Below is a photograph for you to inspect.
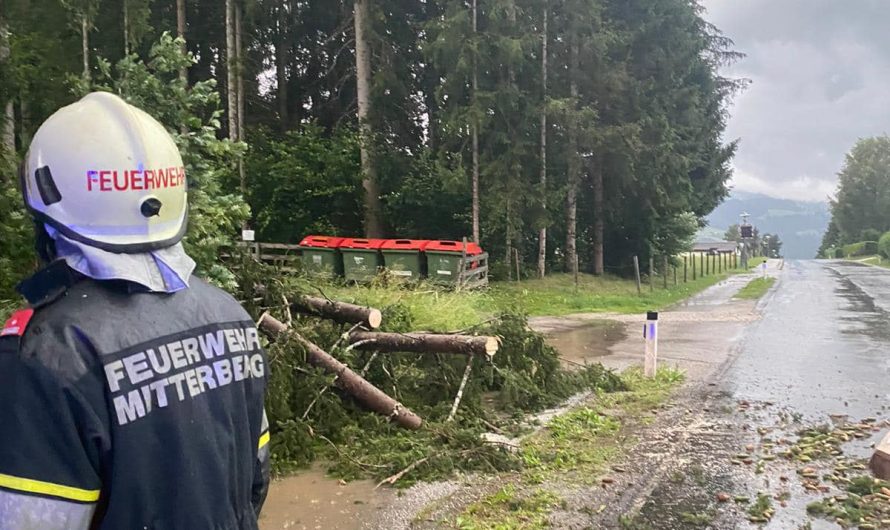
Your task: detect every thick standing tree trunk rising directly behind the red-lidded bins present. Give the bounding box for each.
[353,0,383,237]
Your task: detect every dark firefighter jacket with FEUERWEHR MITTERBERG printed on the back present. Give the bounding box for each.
[0,262,269,530]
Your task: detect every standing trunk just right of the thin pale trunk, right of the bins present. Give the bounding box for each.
[566,36,581,285]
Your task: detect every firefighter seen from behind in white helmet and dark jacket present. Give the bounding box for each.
[0,93,269,530]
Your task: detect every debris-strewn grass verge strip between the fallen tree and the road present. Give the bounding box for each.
[442,368,684,530]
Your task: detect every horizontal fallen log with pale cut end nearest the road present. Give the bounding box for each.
[349,331,499,357]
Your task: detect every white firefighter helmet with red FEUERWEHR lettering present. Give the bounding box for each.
[21,92,187,253]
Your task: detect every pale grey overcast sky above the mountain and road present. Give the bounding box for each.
[703,0,890,201]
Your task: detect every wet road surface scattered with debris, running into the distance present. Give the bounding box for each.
[552,261,890,530]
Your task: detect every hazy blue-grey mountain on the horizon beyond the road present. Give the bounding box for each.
[700,191,831,259]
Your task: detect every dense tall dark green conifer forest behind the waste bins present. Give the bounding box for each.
[0,0,740,288]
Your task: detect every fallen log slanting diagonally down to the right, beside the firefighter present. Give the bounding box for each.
[257,313,423,429]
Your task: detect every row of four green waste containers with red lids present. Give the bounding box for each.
[299,236,482,283]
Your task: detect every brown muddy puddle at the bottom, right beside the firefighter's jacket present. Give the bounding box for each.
[260,468,396,530]
